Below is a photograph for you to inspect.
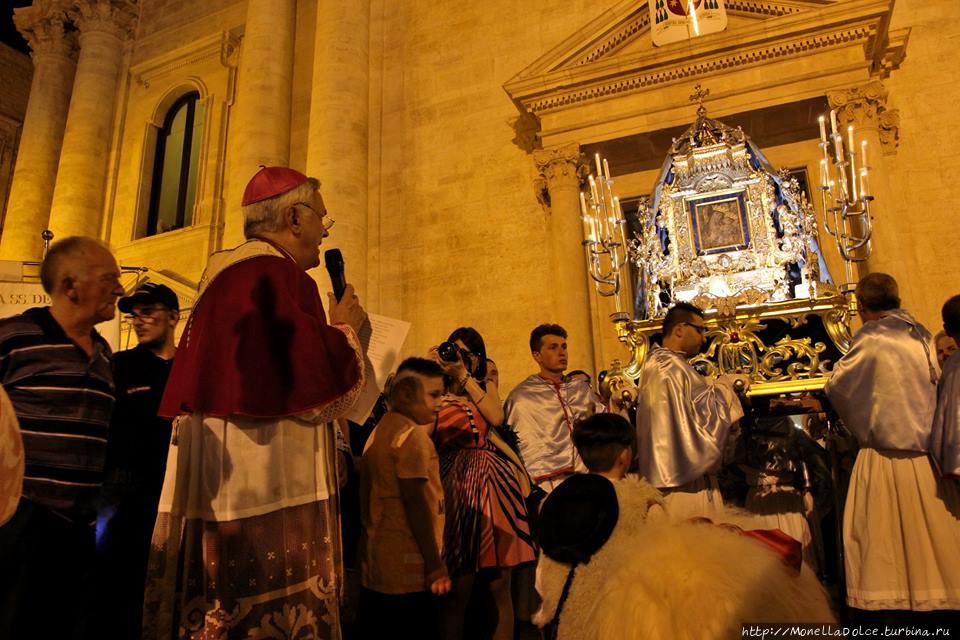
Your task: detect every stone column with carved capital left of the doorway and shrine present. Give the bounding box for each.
[533,144,597,373]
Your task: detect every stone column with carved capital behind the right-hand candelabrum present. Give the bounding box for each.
[827,80,917,289]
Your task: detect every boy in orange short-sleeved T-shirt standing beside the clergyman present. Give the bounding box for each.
[358,358,451,638]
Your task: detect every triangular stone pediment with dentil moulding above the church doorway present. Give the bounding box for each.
[504,0,907,114]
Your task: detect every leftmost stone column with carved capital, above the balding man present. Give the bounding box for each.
[0,6,77,260]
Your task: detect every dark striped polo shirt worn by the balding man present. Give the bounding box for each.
[0,307,114,522]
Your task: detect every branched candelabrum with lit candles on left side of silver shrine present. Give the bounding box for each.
[580,153,627,316]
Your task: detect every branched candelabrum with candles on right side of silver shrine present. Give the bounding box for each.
[817,110,873,286]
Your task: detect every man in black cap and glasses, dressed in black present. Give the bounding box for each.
[98,282,180,638]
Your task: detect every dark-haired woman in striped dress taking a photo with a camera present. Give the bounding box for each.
[433,327,535,640]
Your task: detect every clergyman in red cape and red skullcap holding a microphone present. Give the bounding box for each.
[143,167,366,638]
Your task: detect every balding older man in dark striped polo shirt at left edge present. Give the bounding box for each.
[0,237,123,638]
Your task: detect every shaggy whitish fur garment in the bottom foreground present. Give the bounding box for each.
[534,477,836,640]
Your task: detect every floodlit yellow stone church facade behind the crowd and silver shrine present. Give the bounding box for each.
[0,0,960,388]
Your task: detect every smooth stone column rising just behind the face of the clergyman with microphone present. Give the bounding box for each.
[307,0,370,296]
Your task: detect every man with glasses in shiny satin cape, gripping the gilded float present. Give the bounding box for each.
[637,302,749,518]
